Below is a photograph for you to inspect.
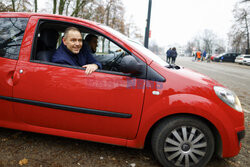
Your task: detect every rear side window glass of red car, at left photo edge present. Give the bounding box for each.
[0,18,28,59]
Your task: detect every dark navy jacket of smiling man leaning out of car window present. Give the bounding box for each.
[52,42,102,69]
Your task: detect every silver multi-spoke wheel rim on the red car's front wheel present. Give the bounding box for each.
[164,126,208,167]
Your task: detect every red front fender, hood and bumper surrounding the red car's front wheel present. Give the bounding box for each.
[128,60,244,157]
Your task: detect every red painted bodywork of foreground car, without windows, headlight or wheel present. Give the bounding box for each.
[0,13,245,157]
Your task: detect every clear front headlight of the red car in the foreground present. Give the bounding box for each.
[214,86,242,112]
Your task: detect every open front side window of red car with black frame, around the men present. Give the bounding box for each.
[30,20,146,78]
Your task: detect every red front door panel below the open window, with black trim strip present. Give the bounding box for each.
[13,18,145,139]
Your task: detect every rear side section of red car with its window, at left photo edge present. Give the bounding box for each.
[0,17,28,122]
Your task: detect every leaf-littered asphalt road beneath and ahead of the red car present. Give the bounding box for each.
[0,57,250,167]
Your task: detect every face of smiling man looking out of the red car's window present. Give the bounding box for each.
[63,30,82,54]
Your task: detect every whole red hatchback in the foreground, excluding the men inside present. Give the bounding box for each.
[0,13,245,166]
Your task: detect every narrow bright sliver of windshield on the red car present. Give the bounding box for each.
[100,25,169,67]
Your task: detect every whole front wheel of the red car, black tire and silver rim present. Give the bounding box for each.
[151,116,215,167]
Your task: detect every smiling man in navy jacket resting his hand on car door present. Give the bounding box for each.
[52,27,102,74]
